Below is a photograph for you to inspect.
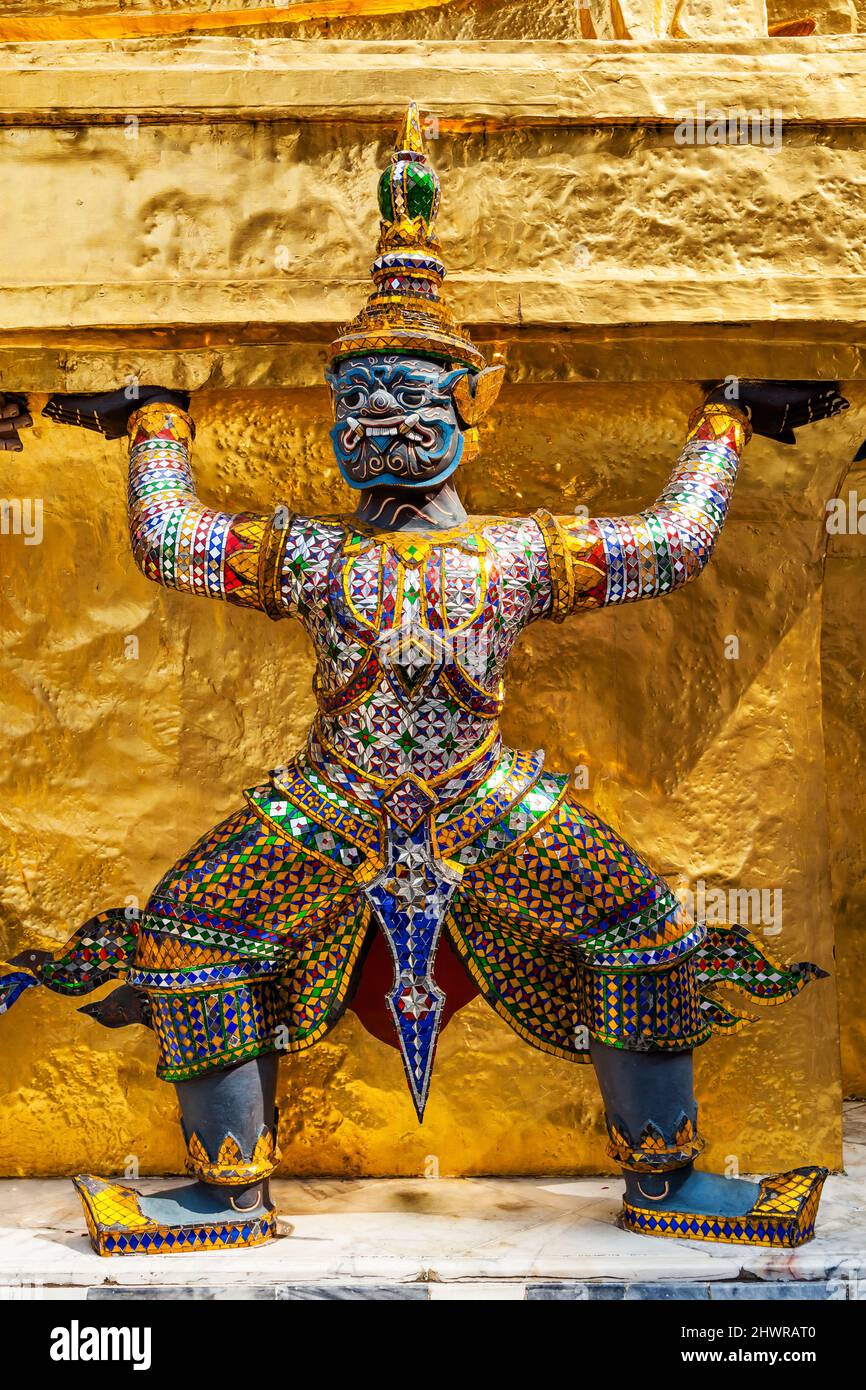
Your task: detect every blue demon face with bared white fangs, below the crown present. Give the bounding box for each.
[327,354,468,488]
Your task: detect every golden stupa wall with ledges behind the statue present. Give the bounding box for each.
[0,0,866,1175]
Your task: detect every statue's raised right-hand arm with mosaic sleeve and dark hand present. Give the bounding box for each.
[535,382,847,620]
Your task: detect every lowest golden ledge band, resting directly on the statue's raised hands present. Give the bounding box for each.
[0,324,866,403]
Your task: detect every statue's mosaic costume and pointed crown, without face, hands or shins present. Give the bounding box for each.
[89,127,767,1113]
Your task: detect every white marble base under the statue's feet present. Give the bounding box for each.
[0,1104,866,1300]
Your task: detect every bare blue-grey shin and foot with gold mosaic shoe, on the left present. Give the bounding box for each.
[74,1054,279,1255]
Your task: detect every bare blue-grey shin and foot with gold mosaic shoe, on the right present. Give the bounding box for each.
[591,1041,827,1248]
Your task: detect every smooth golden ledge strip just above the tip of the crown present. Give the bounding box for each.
[0,35,866,131]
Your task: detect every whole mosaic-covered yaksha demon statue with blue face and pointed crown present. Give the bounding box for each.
[0,107,847,1255]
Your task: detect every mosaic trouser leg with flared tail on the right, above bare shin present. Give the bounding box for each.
[448,795,823,1061]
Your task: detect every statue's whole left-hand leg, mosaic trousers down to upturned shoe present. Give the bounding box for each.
[67,787,366,1255]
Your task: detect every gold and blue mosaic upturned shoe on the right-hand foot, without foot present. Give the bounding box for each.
[620,1168,827,1250]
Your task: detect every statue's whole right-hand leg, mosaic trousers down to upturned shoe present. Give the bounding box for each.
[448,778,826,1245]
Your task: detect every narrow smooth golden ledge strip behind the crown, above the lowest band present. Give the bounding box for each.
[0,276,866,342]
